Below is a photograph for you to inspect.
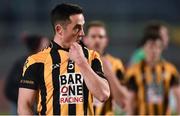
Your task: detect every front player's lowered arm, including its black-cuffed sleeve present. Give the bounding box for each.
[17,57,42,115]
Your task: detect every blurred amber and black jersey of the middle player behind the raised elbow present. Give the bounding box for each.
[94,54,124,115]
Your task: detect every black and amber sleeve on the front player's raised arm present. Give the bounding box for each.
[91,51,105,78]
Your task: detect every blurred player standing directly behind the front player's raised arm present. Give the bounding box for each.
[83,21,129,115]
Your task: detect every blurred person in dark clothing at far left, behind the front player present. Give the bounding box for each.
[5,35,49,114]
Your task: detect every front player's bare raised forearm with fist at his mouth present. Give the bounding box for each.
[69,43,110,102]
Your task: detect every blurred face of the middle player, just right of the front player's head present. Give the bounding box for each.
[87,26,108,53]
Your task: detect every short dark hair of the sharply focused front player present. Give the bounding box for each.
[51,3,83,28]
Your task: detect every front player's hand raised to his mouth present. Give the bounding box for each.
[69,42,87,65]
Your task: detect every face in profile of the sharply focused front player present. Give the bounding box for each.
[59,14,85,46]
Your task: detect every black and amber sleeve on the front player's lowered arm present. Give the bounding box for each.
[19,57,42,90]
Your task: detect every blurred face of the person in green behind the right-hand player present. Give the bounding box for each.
[160,26,169,48]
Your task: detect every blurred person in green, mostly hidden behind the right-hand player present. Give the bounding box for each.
[130,22,169,65]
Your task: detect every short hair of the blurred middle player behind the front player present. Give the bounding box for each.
[86,20,106,33]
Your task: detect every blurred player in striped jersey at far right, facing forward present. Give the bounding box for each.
[125,32,180,115]
